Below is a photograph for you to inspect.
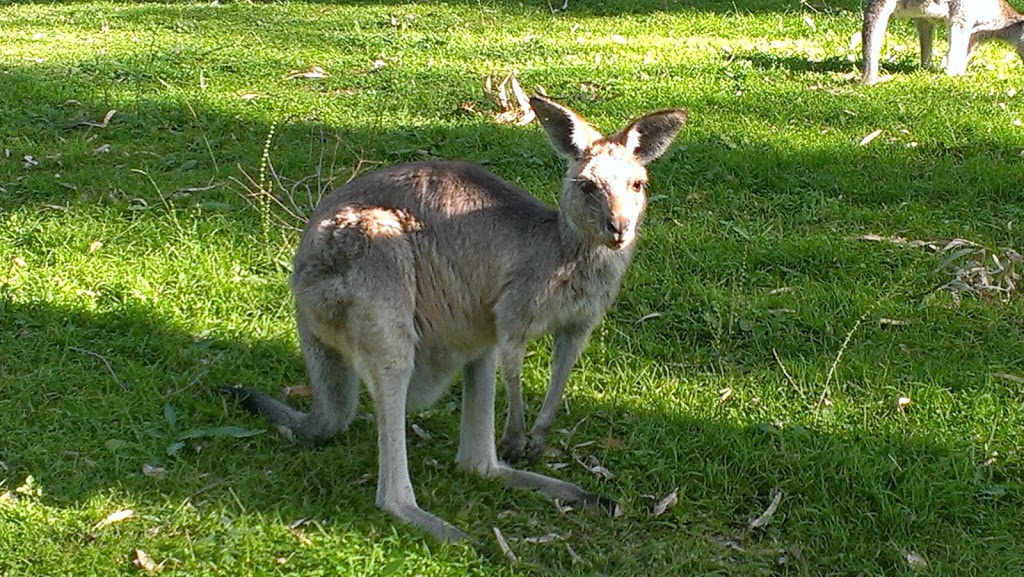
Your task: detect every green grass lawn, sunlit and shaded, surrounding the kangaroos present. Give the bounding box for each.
[0,0,1024,576]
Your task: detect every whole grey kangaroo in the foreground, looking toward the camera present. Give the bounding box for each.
[228,97,687,541]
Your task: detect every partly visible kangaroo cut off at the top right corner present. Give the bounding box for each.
[861,0,1024,85]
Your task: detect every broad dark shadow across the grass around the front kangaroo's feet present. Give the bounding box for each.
[0,302,1024,574]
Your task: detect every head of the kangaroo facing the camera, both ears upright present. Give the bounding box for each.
[529,96,686,250]
